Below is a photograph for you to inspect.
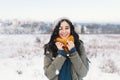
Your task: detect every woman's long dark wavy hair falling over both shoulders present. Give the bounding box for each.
[44,19,80,57]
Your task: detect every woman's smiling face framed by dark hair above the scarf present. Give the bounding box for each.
[59,21,70,38]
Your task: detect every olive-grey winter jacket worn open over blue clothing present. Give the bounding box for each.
[44,43,89,80]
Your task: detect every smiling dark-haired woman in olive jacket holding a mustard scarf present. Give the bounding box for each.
[44,19,88,80]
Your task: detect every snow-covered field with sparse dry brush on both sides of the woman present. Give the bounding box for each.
[0,34,120,80]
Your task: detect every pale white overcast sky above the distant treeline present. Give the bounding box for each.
[0,0,120,22]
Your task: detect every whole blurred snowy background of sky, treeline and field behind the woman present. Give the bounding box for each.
[0,0,120,80]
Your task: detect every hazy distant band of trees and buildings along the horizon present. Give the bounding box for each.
[0,21,120,34]
